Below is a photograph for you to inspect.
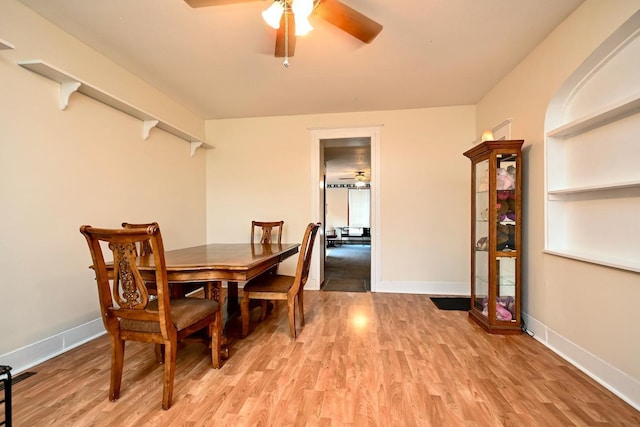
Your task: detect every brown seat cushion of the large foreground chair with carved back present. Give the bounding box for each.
[120,298,220,334]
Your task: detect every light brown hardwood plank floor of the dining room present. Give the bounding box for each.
[13,291,640,427]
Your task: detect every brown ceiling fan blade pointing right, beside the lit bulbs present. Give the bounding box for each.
[314,0,382,43]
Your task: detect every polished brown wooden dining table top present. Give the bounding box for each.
[137,243,300,282]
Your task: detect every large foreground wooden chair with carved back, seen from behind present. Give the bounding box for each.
[80,223,222,409]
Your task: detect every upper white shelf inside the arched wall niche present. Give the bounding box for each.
[547,95,640,138]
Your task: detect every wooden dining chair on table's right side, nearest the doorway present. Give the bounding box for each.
[240,223,320,339]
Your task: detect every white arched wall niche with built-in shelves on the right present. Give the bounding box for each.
[545,11,640,272]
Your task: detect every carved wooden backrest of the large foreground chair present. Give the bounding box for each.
[80,223,176,339]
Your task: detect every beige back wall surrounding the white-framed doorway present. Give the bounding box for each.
[206,106,475,293]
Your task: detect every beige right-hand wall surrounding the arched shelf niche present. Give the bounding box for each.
[478,0,640,388]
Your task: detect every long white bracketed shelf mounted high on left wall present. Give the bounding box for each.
[18,59,213,156]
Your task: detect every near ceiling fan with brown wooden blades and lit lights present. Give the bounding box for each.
[184,0,382,66]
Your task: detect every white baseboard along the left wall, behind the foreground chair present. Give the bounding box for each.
[0,318,107,376]
